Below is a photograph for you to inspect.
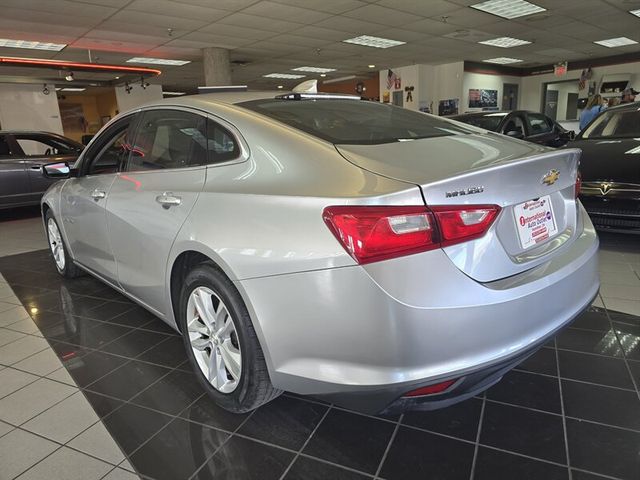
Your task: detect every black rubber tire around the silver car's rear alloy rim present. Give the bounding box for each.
[177,263,282,413]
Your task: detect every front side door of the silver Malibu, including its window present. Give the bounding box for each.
[61,115,135,284]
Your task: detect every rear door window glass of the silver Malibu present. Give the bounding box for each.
[126,109,207,171]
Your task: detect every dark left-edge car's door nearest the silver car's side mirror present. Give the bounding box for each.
[13,133,80,202]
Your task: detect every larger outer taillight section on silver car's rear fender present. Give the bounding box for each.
[323,206,440,264]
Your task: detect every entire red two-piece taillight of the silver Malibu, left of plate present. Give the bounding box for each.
[323,205,500,264]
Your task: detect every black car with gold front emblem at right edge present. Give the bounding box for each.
[567,102,640,233]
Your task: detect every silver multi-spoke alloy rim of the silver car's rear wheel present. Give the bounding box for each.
[187,287,242,393]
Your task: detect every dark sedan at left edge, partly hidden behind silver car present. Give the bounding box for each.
[0,130,84,209]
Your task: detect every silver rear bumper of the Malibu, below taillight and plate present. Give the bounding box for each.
[238,212,599,413]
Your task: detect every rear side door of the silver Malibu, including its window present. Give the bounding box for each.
[107,107,207,316]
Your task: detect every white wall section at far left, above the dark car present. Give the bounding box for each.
[0,83,62,135]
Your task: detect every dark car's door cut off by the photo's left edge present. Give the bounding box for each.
[0,134,29,208]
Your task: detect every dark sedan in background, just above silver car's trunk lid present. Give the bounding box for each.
[450,110,575,148]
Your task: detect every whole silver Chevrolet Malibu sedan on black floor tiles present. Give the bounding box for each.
[42,92,599,413]
